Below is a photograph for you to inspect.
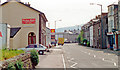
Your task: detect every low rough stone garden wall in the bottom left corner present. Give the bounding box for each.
[0,53,32,70]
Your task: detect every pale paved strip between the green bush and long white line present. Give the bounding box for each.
[36,47,64,68]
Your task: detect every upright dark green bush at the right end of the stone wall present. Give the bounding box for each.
[30,50,39,68]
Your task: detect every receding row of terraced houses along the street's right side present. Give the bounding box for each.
[81,2,120,50]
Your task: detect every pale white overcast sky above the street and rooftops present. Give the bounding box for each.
[1,0,118,29]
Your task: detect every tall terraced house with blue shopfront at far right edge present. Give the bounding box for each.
[107,4,118,50]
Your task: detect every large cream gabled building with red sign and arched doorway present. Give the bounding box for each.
[0,0,50,49]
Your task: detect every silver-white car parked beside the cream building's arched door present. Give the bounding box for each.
[18,44,47,55]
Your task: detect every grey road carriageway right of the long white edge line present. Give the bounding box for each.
[63,44,118,68]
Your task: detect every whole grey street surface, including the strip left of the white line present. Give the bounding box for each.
[37,43,118,70]
